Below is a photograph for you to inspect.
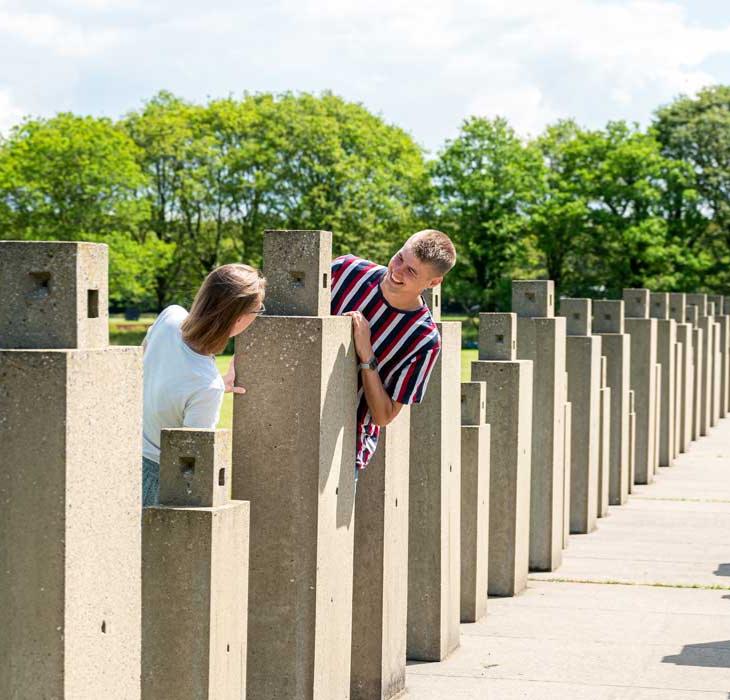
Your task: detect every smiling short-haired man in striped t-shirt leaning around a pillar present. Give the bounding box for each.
[332,229,456,474]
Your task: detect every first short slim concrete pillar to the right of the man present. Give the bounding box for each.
[461,382,490,622]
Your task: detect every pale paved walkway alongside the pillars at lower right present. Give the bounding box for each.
[407,419,730,700]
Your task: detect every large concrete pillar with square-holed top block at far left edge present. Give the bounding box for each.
[0,241,142,700]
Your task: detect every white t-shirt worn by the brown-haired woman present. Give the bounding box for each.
[142,306,225,462]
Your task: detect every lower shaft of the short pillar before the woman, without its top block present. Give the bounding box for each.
[142,498,250,700]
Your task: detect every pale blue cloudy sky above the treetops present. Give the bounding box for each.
[0,0,730,151]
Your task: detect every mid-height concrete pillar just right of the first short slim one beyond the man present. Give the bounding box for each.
[471,313,533,596]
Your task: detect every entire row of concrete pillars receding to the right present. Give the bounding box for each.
[0,237,730,700]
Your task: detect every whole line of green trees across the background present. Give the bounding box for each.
[0,86,730,309]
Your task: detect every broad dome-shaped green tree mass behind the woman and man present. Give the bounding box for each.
[124,92,428,306]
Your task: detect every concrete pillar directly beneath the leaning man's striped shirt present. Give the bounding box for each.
[350,406,411,700]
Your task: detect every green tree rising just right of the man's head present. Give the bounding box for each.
[433,117,544,309]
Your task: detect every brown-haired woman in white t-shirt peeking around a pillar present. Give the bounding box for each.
[142,264,266,506]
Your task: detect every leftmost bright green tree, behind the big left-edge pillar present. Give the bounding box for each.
[0,113,154,303]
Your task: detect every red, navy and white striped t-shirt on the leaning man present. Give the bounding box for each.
[332,255,441,469]
